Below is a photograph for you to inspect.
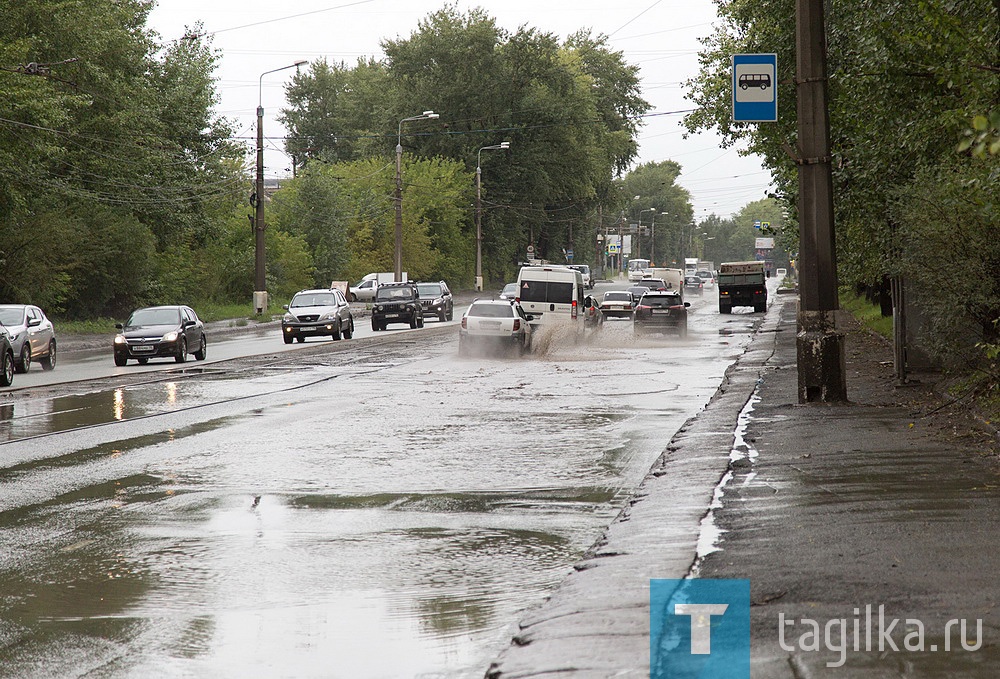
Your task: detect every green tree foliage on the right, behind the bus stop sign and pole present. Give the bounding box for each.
[686,0,1000,378]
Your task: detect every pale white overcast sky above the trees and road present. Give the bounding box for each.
[150,0,770,220]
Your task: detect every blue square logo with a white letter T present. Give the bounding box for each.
[649,579,750,679]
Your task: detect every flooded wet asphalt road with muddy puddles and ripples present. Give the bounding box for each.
[0,288,753,678]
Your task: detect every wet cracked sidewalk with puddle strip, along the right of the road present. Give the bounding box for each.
[487,295,1000,679]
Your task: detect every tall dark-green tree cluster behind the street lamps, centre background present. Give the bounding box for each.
[283,6,649,282]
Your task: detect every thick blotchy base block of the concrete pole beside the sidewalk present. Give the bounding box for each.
[796,310,847,403]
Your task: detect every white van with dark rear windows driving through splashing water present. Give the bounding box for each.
[517,266,584,331]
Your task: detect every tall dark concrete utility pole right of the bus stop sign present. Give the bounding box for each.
[795,0,847,403]
